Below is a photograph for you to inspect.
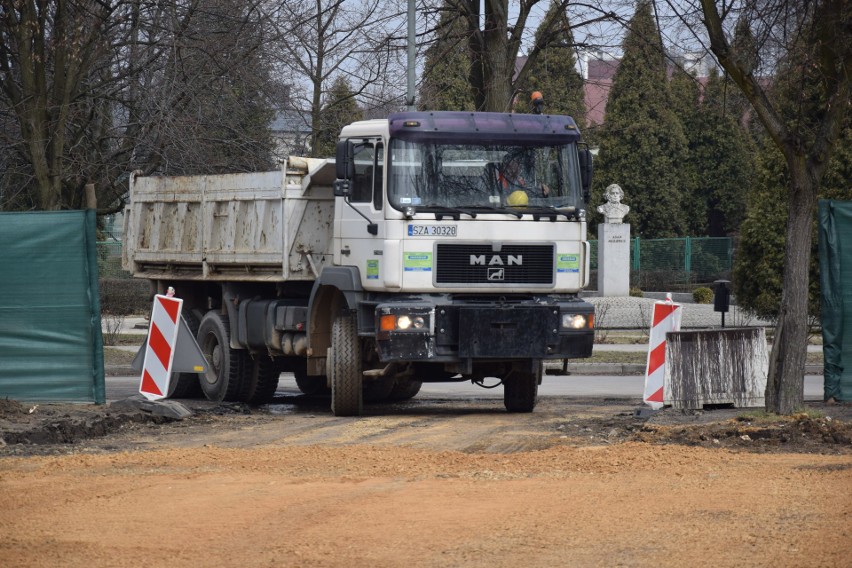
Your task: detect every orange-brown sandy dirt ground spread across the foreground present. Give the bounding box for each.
[0,397,852,567]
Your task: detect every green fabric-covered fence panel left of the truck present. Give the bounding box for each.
[0,210,105,403]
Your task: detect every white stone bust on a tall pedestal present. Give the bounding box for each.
[598,184,630,297]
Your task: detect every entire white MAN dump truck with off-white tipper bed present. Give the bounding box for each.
[123,112,594,416]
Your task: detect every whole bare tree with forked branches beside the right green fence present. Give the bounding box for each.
[667,0,852,414]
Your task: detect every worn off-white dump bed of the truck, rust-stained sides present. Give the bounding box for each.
[122,158,334,282]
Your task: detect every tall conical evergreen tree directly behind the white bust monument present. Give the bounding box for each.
[592,0,688,238]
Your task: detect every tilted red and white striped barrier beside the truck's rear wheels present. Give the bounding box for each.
[139,294,183,400]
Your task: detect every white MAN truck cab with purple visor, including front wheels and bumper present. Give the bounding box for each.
[307,112,594,415]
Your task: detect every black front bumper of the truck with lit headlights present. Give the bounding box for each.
[375,295,594,362]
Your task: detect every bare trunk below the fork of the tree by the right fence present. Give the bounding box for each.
[766,157,816,414]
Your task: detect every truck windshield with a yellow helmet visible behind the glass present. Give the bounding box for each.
[388,139,581,212]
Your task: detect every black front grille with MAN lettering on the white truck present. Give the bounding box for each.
[435,243,554,286]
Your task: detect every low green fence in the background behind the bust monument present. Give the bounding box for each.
[590,237,733,290]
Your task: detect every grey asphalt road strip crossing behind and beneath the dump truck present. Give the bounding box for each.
[106,373,823,401]
